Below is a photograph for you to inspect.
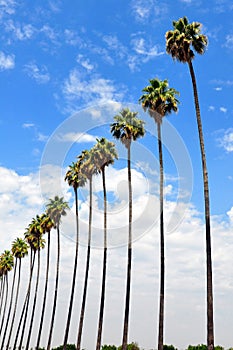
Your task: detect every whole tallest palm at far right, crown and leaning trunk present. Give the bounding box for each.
[166,17,214,350]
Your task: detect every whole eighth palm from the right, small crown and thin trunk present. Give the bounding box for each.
[36,213,54,349]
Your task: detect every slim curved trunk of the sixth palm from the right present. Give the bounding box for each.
[63,187,79,350]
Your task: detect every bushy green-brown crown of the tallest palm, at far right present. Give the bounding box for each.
[166,17,208,63]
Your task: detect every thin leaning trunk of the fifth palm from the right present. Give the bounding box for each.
[77,177,92,350]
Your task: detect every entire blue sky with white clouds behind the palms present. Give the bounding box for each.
[0,0,233,350]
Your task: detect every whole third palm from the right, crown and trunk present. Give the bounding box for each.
[111,108,145,350]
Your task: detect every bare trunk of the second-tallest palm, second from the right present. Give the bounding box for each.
[157,121,165,350]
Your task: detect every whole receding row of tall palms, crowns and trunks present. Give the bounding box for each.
[0,17,214,350]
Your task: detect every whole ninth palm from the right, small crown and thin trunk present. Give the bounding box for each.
[25,215,45,350]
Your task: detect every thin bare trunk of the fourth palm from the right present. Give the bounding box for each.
[96,167,107,350]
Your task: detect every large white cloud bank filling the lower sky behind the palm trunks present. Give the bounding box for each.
[0,165,233,349]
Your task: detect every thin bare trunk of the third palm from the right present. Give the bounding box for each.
[122,145,132,350]
